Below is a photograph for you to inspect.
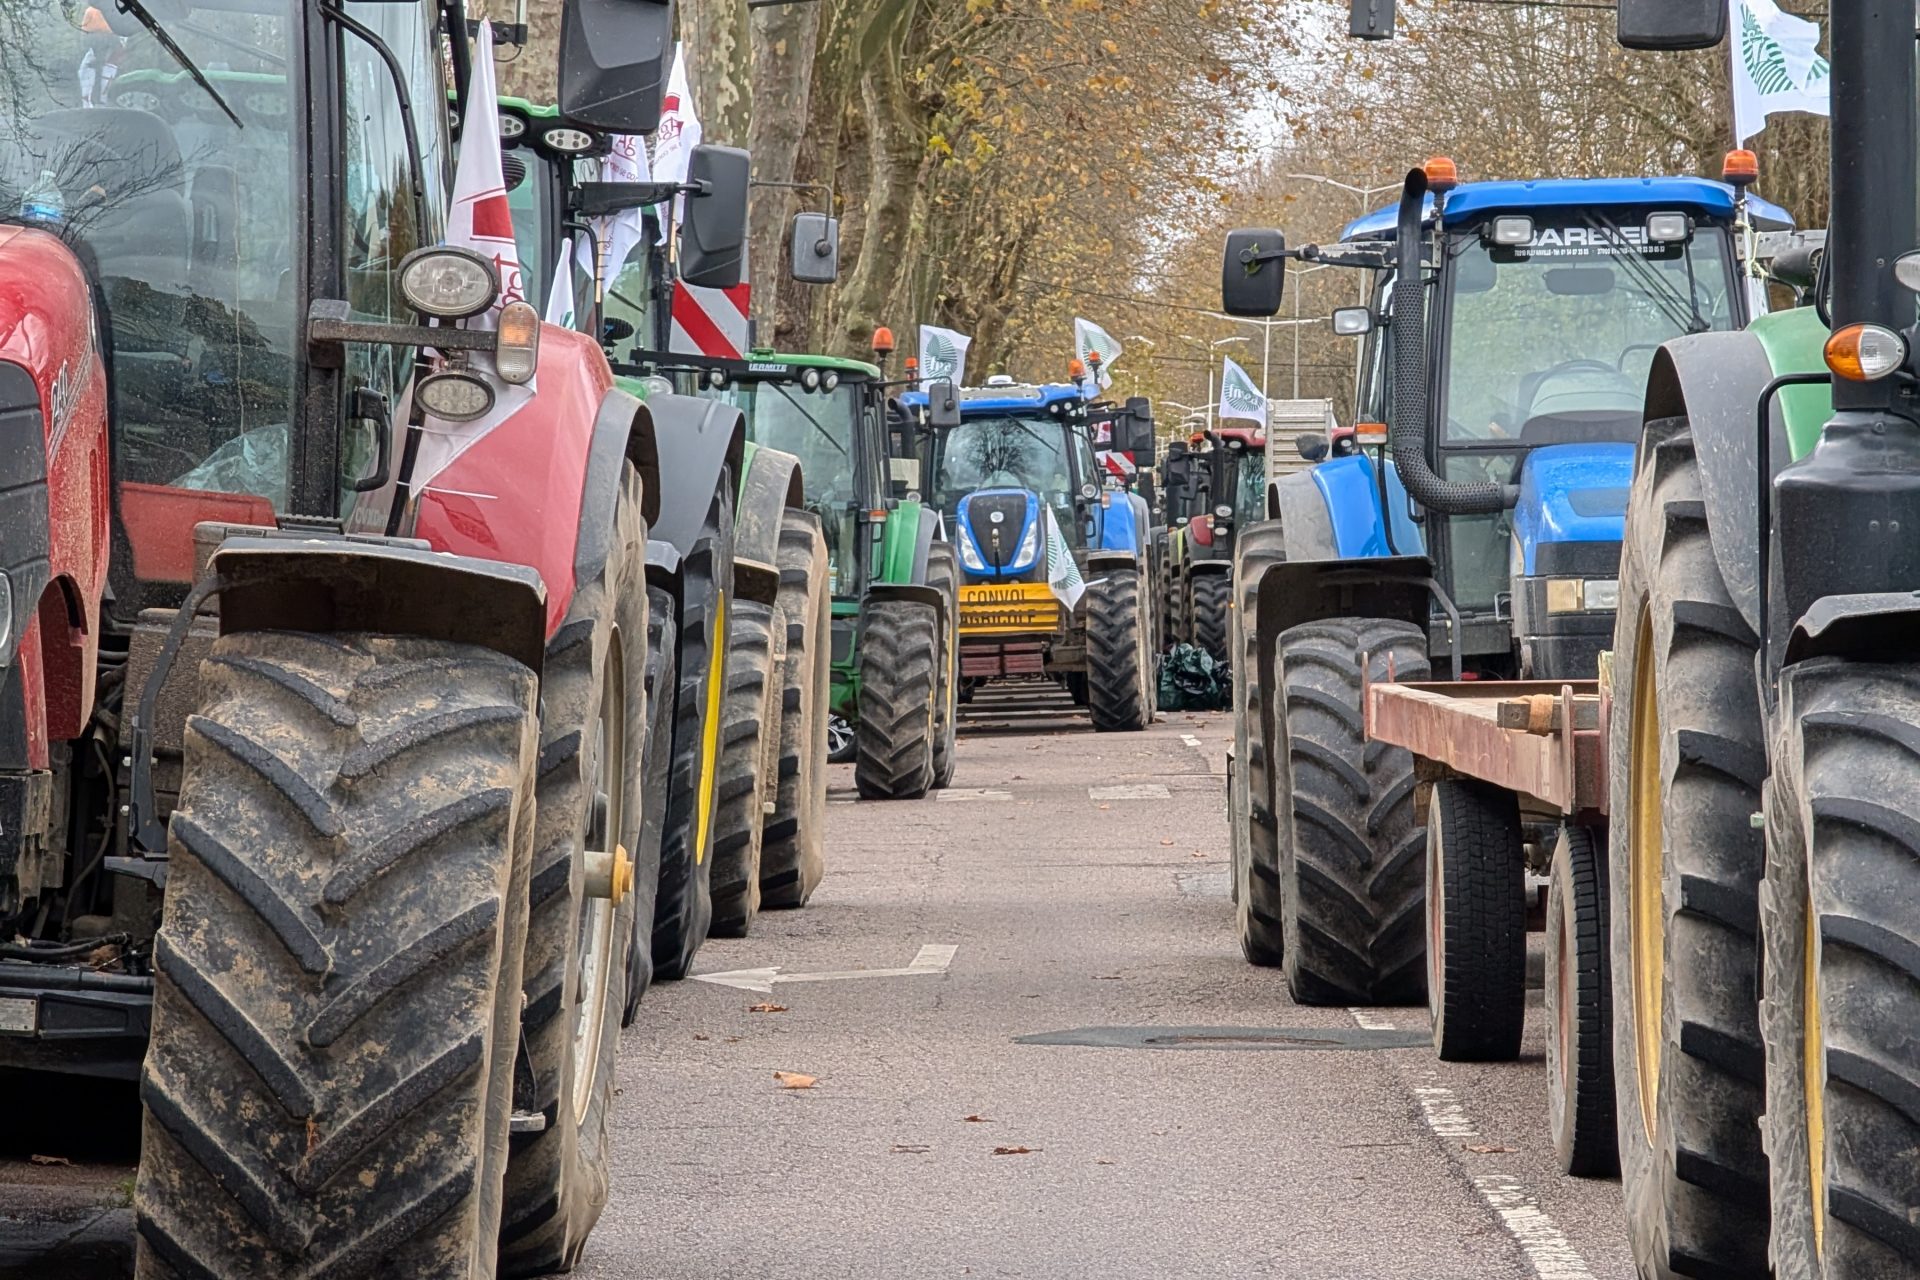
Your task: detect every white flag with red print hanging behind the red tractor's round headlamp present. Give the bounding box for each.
[413,21,534,491]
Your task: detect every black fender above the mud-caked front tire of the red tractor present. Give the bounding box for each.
[211,535,547,674]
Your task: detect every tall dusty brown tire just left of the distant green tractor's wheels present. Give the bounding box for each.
[760,510,833,910]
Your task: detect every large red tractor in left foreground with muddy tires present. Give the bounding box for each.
[0,0,745,1280]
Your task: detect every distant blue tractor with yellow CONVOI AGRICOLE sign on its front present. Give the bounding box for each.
[900,376,1156,731]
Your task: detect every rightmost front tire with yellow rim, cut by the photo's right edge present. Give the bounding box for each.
[1761,658,1920,1280]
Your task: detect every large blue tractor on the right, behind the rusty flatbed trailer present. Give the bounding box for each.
[1223,161,1788,1013]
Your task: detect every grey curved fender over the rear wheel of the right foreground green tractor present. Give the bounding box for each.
[1634,332,1789,635]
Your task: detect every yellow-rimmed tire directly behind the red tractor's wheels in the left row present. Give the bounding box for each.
[653,474,733,983]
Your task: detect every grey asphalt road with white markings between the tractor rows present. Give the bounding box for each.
[0,699,1632,1280]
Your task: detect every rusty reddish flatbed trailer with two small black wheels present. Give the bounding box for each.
[1361,671,1619,1176]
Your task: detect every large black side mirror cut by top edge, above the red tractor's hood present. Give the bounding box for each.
[561,0,674,134]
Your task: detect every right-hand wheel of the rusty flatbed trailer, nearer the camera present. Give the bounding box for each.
[1546,827,1620,1178]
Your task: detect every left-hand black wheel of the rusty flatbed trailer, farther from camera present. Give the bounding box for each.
[1427,777,1526,1063]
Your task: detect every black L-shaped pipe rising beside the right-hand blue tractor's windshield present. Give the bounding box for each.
[1386,169,1521,516]
